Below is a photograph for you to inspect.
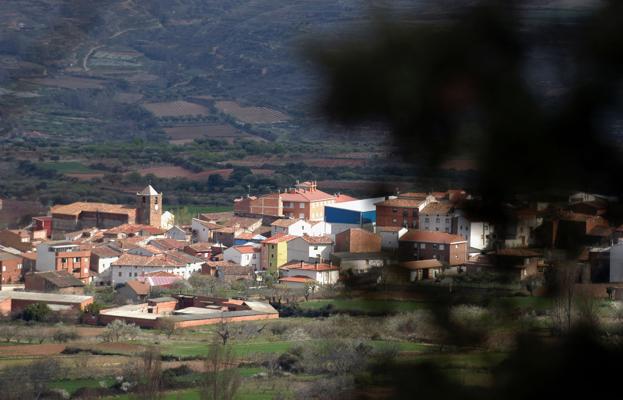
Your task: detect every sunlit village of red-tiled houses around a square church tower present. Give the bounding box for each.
[0,181,623,398]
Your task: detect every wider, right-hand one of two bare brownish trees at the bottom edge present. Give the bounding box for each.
[199,341,241,400]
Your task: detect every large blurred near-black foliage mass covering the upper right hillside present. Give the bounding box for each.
[313,1,623,213]
